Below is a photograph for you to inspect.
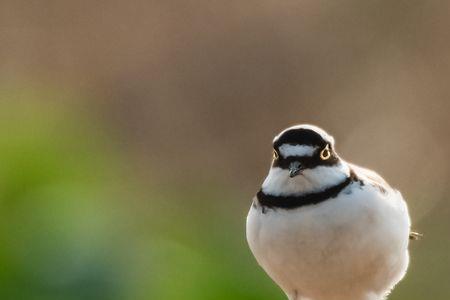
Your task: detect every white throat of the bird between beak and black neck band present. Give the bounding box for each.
[261,161,350,196]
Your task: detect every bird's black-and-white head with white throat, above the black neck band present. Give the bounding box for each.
[262,125,349,195]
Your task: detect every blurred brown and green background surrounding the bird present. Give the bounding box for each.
[0,0,450,300]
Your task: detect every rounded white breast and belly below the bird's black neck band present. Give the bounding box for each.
[247,185,410,300]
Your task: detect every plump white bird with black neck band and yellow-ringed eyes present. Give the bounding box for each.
[246,124,421,300]
